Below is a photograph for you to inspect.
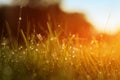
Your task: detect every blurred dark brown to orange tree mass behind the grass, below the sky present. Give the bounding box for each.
[0,4,95,43]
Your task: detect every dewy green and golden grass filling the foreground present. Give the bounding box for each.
[0,23,120,80]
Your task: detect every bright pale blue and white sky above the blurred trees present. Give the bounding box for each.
[0,0,120,33]
